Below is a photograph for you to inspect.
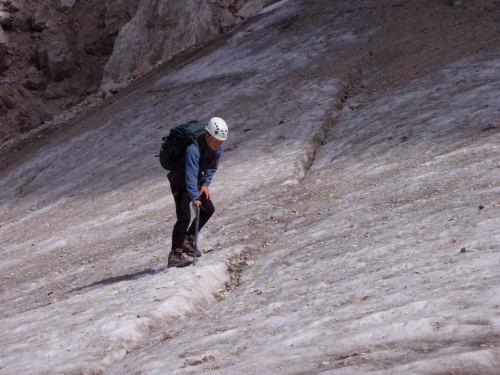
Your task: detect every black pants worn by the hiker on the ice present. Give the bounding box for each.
[170,184,215,251]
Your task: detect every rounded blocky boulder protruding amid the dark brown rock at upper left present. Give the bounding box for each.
[36,42,76,81]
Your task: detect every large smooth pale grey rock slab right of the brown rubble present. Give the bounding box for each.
[103,0,237,83]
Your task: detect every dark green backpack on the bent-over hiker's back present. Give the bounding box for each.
[159,120,206,171]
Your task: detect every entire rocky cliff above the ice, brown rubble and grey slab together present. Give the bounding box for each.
[0,0,275,149]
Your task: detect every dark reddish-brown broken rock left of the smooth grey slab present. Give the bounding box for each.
[0,0,143,147]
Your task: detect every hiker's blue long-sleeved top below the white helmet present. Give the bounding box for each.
[168,139,222,201]
